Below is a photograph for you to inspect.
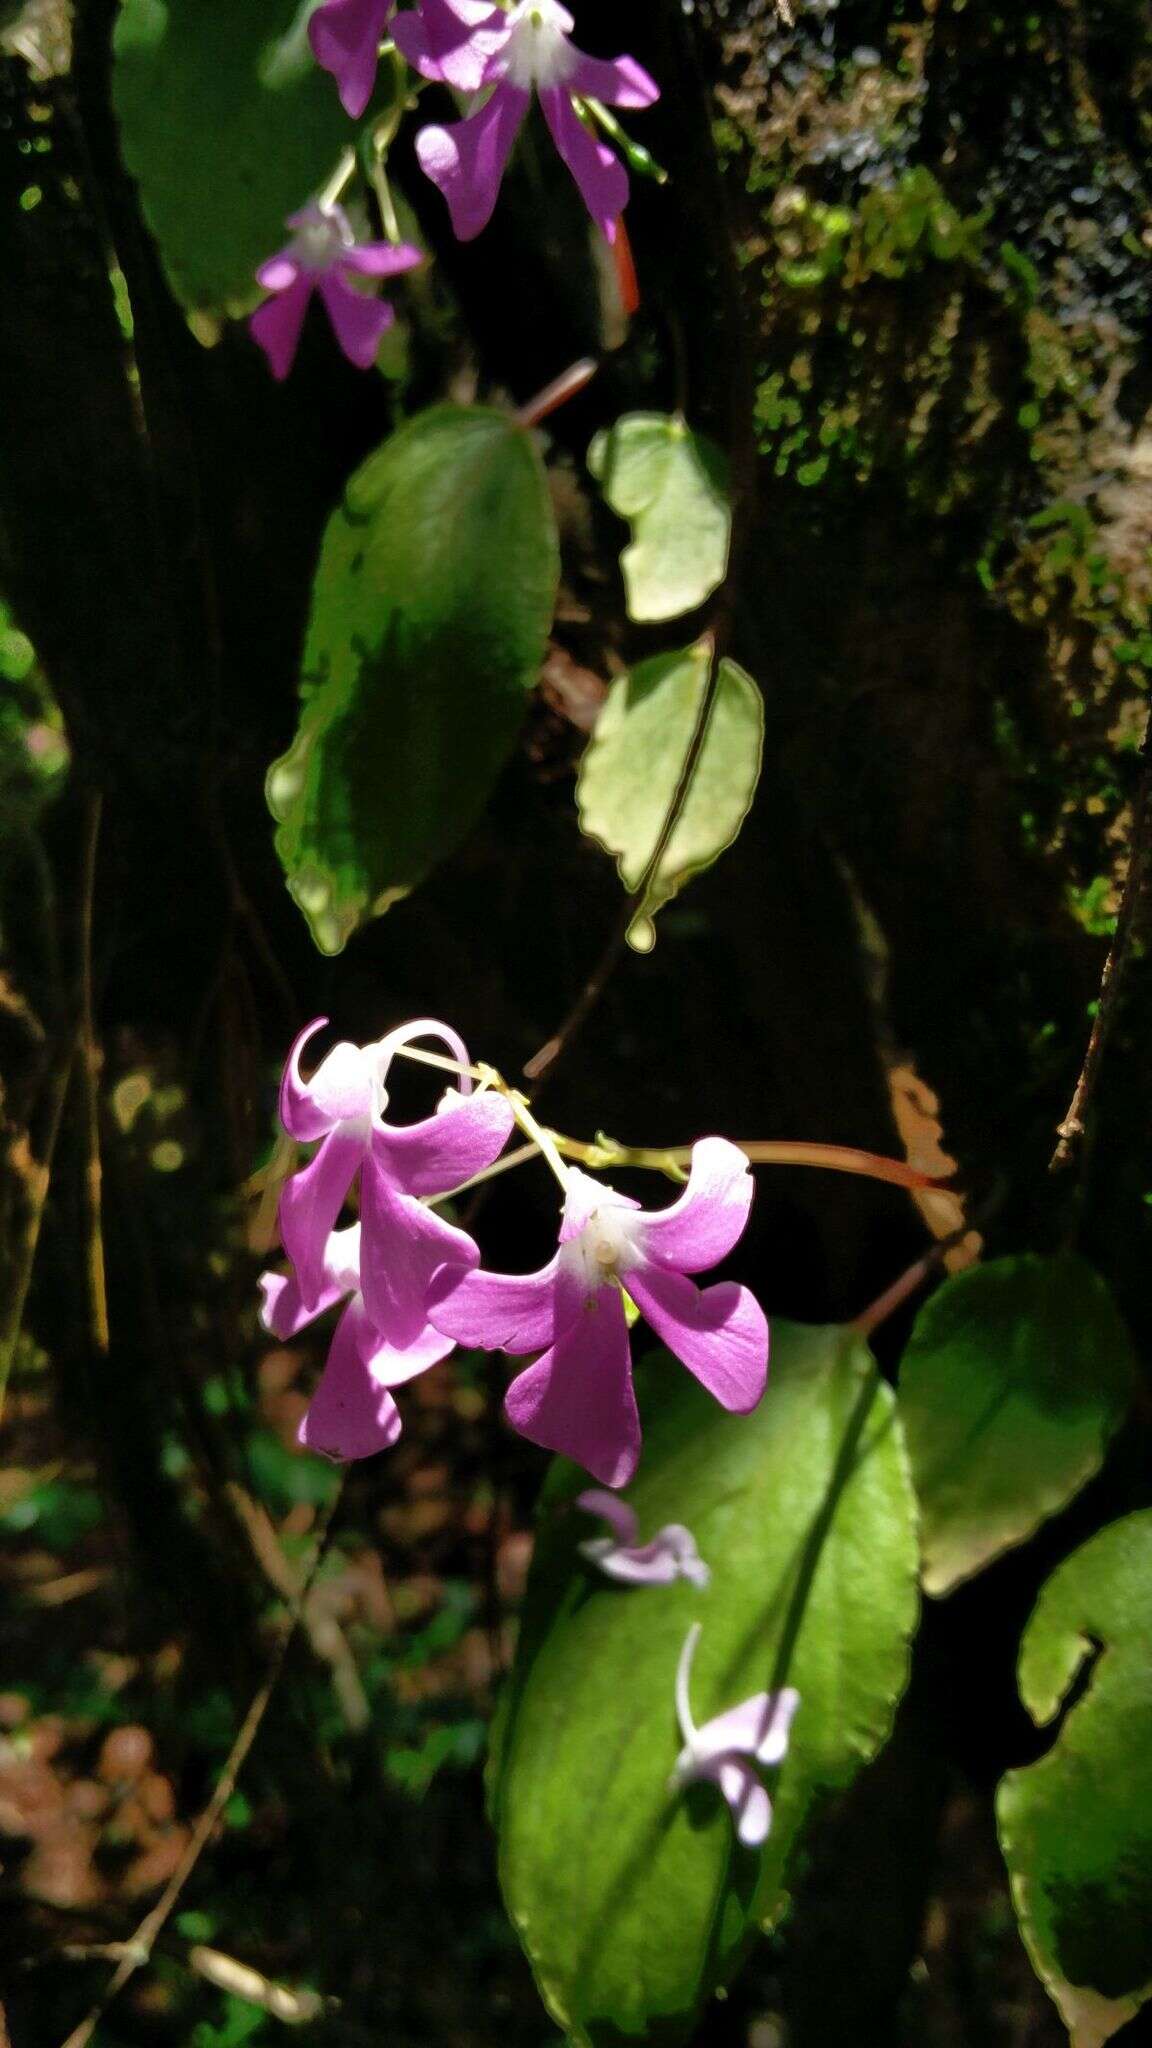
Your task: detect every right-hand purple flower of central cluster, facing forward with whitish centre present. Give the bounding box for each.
[428,1139,769,1487]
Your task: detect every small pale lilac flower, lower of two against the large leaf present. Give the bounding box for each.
[672,1622,799,1849]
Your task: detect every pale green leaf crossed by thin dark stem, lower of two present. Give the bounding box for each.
[576,639,765,952]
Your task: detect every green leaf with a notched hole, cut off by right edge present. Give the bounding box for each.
[996,1511,1152,2048]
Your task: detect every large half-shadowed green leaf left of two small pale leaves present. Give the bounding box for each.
[269,406,560,952]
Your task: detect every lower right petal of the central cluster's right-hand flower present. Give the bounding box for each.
[625,1266,769,1415]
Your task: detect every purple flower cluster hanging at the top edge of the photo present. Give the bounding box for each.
[252,0,660,377]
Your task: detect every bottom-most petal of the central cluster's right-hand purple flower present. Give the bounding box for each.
[504,1286,640,1487]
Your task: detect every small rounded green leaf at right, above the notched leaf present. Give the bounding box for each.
[900,1253,1134,1593]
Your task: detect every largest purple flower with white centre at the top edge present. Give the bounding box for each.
[392,0,660,242]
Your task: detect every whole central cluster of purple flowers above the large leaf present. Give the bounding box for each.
[262,1018,769,1487]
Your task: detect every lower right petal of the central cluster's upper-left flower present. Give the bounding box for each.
[361,1157,480,1350]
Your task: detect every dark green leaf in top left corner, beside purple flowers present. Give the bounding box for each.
[113,0,351,313]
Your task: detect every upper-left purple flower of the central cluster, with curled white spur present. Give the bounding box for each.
[279,1018,515,1350]
